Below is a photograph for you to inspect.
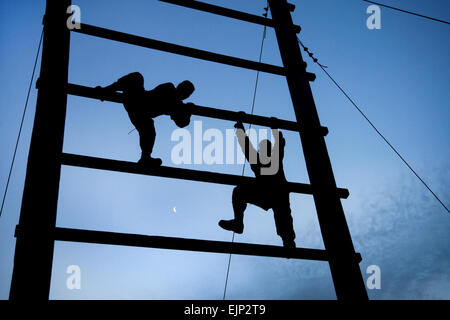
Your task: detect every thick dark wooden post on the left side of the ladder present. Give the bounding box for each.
[10,0,71,301]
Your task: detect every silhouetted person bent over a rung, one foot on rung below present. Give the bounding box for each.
[97,72,195,166]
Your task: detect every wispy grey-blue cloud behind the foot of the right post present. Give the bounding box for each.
[274,168,450,299]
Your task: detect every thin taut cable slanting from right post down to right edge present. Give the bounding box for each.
[297,38,450,213]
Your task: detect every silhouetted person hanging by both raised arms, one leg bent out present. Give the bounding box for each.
[219,122,295,248]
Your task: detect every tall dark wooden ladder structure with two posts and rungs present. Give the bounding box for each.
[10,0,368,300]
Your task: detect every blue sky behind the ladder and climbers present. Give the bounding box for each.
[0,0,450,299]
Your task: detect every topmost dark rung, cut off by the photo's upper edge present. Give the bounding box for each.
[159,0,301,33]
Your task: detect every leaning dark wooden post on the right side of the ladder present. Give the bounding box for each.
[269,0,368,300]
